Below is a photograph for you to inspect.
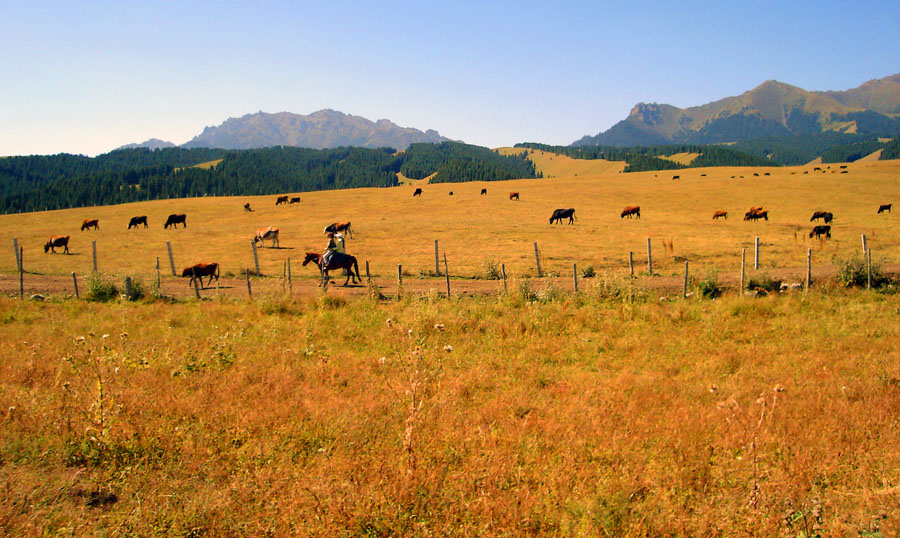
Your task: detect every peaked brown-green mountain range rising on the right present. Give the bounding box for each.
[573,74,900,147]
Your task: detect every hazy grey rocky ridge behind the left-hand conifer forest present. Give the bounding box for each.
[182,109,449,150]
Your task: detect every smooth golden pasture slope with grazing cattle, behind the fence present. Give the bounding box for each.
[0,159,900,288]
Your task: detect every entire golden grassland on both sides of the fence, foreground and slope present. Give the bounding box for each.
[0,155,900,538]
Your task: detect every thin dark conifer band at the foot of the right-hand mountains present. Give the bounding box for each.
[515,142,778,172]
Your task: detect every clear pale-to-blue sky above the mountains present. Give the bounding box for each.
[0,0,900,156]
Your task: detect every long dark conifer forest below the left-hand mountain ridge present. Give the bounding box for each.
[0,142,535,213]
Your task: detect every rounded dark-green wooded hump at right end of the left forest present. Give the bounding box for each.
[400,142,538,183]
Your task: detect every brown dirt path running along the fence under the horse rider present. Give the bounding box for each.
[0,264,900,299]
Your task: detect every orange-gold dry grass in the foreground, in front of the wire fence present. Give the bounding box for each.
[0,288,900,537]
